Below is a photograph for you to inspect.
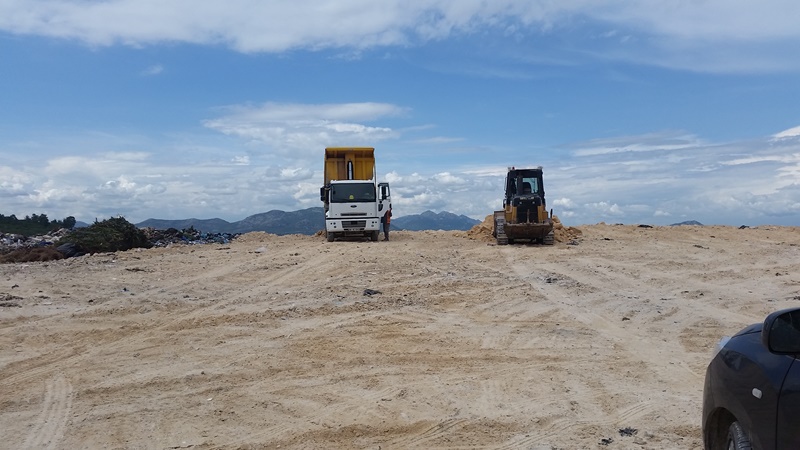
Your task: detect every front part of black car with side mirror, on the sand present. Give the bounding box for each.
[703,308,800,450]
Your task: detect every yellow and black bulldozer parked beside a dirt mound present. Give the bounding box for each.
[492,166,555,245]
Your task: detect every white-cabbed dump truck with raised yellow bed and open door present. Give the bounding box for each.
[320,147,391,242]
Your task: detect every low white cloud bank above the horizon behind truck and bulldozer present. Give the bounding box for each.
[0,111,800,226]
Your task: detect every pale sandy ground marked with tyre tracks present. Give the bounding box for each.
[0,224,800,450]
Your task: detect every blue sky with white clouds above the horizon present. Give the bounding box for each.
[0,0,800,226]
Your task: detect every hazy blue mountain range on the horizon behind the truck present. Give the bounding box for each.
[135,207,480,235]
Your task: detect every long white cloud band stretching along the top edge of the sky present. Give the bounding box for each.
[0,0,800,71]
